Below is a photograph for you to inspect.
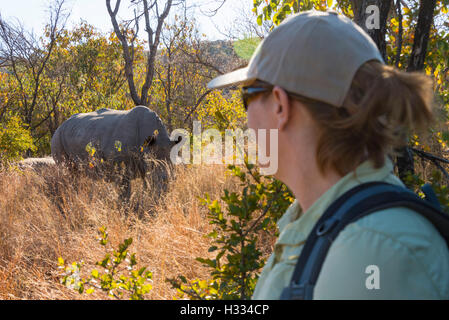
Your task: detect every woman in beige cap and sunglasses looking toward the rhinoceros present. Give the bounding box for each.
[209,12,449,299]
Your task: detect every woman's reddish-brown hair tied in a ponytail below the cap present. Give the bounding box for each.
[303,61,434,176]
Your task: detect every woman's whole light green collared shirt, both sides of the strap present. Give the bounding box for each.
[252,157,449,299]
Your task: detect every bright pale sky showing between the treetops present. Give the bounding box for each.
[0,0,245,40]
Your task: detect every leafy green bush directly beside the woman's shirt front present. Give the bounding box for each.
[167,164,293,300]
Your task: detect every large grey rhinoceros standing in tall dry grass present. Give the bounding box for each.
[51,106,181,200]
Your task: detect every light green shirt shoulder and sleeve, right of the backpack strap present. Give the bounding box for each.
[314,207,449,299]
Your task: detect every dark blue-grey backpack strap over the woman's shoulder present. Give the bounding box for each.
[281,182,449,299]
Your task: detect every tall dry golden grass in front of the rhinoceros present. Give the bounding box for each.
[0,162,270,299]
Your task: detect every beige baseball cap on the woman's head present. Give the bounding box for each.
[207,11,384,107]
